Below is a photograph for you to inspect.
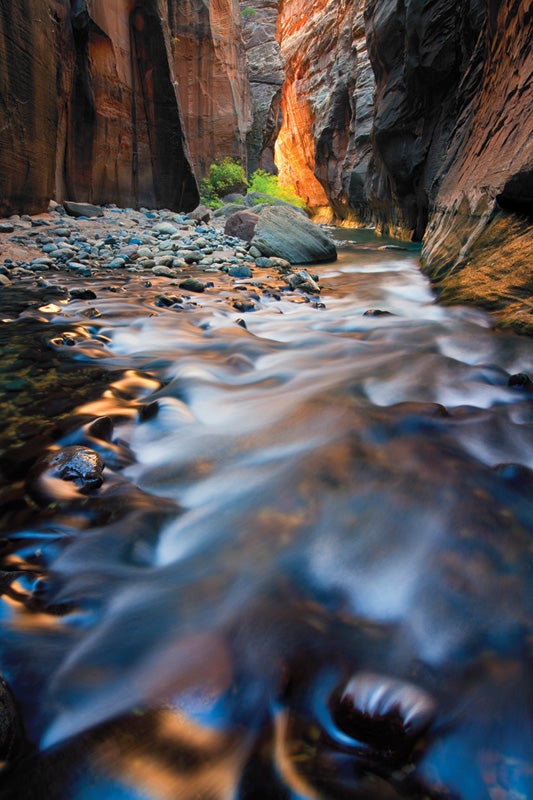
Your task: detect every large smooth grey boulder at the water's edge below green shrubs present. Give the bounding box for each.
[252,206,337,264]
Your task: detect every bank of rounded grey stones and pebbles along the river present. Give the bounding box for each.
[0,206,335,321]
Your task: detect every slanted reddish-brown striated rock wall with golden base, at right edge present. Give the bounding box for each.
[423,0,533,334]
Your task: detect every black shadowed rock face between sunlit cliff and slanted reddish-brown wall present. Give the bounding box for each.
[365,0,486,239]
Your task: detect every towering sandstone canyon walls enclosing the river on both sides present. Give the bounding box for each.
[0,0,533,331]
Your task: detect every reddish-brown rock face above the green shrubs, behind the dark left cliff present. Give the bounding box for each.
[170,0,252,177]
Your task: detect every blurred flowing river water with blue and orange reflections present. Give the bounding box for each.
[0,231,533,800]
